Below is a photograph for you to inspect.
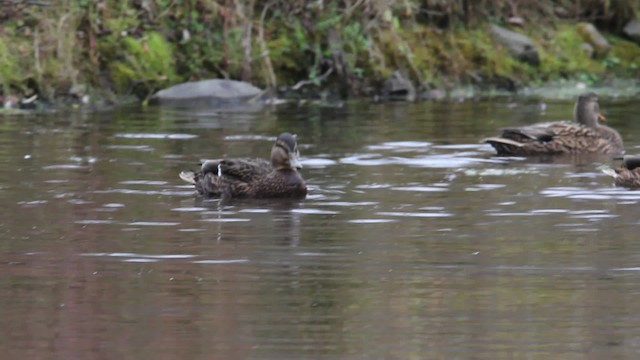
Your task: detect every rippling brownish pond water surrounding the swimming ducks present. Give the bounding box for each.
[0,99,640,359]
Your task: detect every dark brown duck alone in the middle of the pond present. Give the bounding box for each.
[179,132,307,199]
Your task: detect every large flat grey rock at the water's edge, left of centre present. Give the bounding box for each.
[153,79,262,103]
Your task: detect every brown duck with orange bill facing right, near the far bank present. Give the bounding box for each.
[484,92,623,156]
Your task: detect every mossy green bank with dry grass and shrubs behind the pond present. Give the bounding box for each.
[0,0,640,104]
